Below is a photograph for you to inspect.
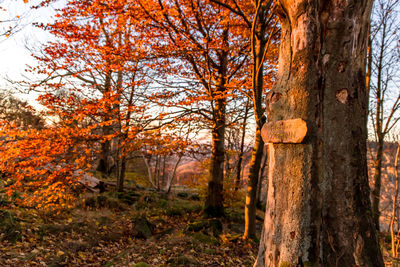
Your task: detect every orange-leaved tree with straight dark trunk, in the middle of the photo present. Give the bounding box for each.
[139,0,248,217]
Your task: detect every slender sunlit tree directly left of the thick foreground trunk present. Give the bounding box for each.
[211,0,277,238]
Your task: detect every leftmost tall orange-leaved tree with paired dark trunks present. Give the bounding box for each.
[25,1,158,191]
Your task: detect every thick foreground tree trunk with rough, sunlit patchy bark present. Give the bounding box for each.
[255,0,383,267]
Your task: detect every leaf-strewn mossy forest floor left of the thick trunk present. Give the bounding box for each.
[0,188,263,267]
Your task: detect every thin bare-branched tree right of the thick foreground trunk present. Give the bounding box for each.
[369,0,400,230]
